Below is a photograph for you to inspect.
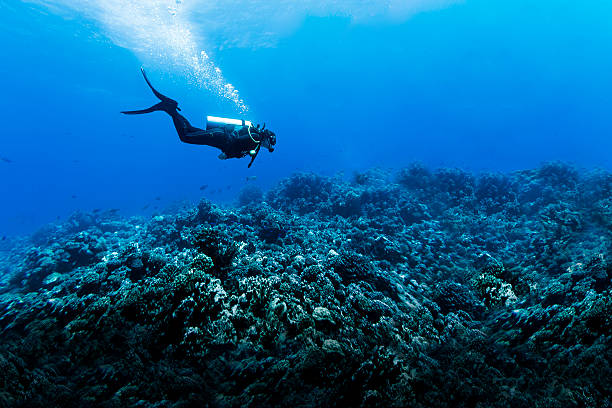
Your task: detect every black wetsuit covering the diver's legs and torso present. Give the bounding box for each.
[166,110,259,159]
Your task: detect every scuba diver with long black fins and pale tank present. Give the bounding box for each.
[121,68,276,167]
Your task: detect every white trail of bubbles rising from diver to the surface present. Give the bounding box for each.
[30,0,249,113]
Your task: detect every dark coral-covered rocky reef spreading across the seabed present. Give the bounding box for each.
[0,163,612,407]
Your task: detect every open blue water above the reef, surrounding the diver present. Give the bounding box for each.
[0,0,612,235]
